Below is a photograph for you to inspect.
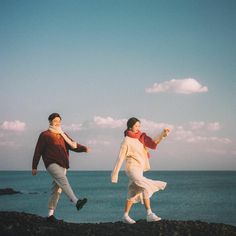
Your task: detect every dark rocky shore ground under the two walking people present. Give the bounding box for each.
[0,211,236,236]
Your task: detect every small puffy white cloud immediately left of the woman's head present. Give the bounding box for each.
[93,116,126,128]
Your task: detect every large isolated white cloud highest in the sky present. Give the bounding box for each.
[146,78,208,94]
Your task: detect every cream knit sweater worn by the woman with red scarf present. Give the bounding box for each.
[111,136,150,183]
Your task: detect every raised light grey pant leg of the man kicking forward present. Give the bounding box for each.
[47,163,78,203]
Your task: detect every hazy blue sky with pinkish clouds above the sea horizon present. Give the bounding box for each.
[0,0,236,170]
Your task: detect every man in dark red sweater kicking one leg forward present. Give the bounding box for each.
[32,113,90,221]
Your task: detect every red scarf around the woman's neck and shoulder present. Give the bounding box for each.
[124,129,157,157]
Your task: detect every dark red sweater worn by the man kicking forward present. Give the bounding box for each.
[32,130,87,169]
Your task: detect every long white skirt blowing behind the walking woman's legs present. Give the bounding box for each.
[126,166,167,204]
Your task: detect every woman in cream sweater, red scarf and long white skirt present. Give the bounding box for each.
[111,117,170,224]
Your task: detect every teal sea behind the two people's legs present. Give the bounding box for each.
[0,171,236,226]
